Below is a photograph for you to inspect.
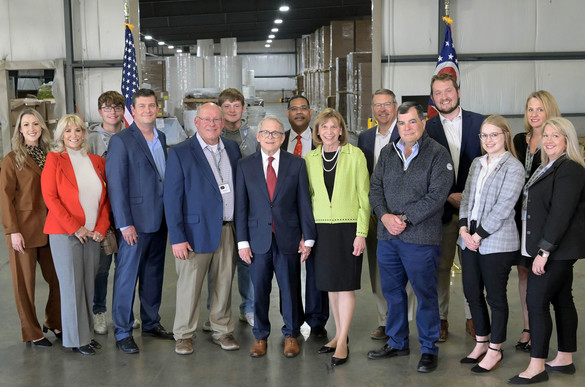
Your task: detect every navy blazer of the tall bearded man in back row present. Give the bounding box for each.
[425,110,486,223]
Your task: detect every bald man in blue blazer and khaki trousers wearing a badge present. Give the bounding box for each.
[164,103,242,355]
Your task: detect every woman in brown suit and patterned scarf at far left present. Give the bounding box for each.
[0,109,61,347]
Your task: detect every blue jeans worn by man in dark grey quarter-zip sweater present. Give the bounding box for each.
[377,239,441,355]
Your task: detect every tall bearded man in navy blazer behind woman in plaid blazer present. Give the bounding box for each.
[426,74,485,342]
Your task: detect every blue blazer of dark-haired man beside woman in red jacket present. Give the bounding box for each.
[106,123,167,233]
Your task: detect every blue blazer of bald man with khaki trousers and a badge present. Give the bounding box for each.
[164,134,242,253]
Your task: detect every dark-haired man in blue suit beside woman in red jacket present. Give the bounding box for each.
[106,89,172,353]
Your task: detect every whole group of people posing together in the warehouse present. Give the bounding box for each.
[0,74,585,384]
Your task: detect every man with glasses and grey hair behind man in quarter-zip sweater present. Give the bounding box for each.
[358,89,402,340]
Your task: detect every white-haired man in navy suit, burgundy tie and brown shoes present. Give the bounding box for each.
[236,116,316,357]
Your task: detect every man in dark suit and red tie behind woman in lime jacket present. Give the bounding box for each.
[280,95,329,338]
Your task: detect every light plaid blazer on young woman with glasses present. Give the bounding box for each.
[458,152,525,254]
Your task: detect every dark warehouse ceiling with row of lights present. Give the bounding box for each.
[139,0,371,47]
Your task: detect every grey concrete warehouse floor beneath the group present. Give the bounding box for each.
[0,105,585,387]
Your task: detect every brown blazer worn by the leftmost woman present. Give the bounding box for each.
[0,152,49,248]
